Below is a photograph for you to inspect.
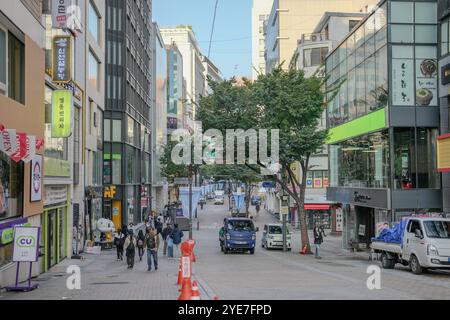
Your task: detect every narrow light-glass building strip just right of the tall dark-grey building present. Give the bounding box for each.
[151,22,168,212]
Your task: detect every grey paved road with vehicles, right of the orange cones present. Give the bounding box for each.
[192,200,450,300]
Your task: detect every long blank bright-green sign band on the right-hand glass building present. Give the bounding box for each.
[327,108,387,144]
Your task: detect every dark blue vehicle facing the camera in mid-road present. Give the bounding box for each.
[219,218,259,254]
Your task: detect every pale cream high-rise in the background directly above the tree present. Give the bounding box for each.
[252,0,273,80]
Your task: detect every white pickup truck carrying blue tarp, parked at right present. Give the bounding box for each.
[372,217,450,274]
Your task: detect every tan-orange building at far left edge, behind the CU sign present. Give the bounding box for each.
[0,0,45,288]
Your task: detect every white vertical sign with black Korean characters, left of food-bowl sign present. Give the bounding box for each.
[392,59,415,106]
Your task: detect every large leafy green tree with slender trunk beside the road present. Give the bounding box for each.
[198,70,327,253]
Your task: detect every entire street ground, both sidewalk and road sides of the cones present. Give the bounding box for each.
[0,203,450,300]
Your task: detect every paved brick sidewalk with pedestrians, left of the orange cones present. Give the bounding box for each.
[0,250,187,300]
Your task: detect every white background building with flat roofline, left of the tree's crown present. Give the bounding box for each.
[161,26,206,130]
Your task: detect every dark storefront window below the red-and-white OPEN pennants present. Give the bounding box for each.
[0,152,24,221]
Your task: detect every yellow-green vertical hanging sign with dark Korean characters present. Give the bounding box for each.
[52,90,73,138]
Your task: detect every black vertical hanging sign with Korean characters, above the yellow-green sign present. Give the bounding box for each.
[52,36,72,83]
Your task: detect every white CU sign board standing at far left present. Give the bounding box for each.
[13,226,39,262]
